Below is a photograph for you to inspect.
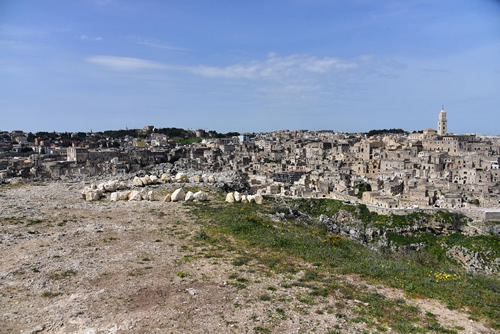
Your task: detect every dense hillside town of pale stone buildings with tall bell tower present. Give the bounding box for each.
[0,107,500,217]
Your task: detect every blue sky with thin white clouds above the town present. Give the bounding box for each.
[0,0,500,135]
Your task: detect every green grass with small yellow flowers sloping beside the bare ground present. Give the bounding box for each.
[191,200,500,333]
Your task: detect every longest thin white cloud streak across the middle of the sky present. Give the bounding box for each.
[86,53,407,89]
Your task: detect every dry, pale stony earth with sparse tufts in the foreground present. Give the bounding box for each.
[0,182,491,334]
